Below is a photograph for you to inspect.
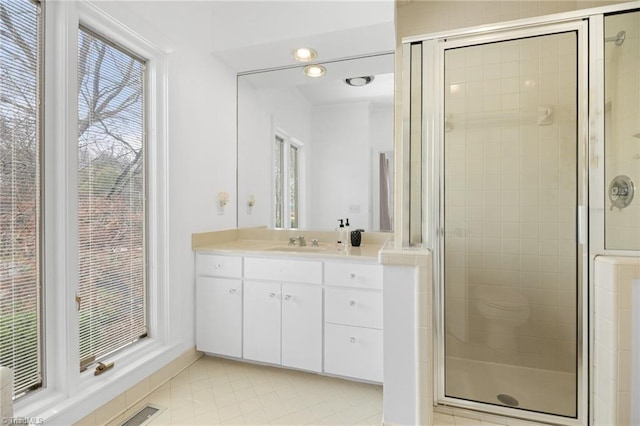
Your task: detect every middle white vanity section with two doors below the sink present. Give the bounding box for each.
[243,258,322,372]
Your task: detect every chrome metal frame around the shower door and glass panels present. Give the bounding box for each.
[402,1,640,425]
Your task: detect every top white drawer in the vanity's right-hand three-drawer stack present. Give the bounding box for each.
[324,262,382,289]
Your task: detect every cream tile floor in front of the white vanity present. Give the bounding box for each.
[141,356,382,426]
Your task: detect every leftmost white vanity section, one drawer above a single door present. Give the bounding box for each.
[196,253,242,358]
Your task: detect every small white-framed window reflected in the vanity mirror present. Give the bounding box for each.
[273,134,302,228]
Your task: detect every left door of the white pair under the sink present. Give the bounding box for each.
[243,281,280,364]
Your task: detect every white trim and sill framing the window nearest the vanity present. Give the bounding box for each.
[14,1,172,424]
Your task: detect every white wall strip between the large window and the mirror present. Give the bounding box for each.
[168,48,236,349]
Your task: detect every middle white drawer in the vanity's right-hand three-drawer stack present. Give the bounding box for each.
[324,287,382,329]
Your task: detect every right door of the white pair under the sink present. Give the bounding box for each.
[282,284,322,372]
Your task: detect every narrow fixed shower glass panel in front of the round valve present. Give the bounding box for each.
[604,12,640,250]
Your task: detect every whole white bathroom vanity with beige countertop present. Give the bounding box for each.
[193,229,390,383]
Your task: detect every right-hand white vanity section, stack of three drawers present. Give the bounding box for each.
[324,262,383,382]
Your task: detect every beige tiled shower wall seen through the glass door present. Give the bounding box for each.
[445,32,576,371]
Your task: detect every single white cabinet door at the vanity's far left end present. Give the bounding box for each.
[196,277,242,358]
